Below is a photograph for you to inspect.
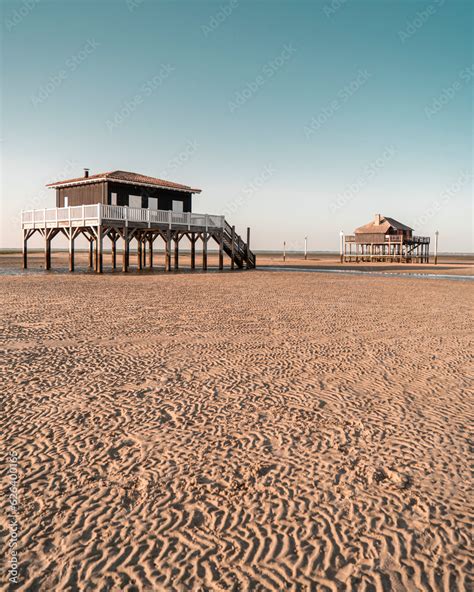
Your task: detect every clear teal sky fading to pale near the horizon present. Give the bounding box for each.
[0,0,474,252]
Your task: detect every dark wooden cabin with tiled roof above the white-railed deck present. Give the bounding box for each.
[47,169,201,212]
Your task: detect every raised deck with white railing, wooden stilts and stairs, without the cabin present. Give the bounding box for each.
[21,204,256,273]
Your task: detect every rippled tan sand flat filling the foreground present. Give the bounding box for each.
[0,266,474,592]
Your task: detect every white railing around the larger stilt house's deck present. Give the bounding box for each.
[21,204,225,229]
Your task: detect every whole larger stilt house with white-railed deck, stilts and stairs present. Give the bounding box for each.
[21,169,255,273]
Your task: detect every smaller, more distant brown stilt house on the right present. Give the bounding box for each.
[341,214,430,263]
